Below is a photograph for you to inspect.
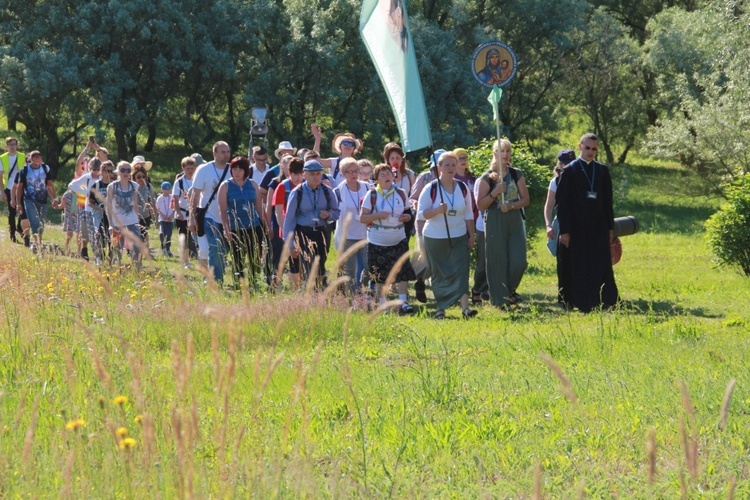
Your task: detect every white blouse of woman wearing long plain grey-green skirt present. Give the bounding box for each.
[417,180,474,240]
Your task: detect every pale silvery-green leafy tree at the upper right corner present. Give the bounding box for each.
[648,1,750,194]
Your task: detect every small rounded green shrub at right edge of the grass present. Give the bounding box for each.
[706,174,750,276]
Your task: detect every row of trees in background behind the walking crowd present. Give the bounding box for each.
[0,0,750,192]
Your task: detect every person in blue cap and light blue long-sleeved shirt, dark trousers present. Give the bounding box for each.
[284,160,339,287]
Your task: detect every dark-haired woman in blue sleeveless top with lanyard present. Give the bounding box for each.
[216,156,268,287]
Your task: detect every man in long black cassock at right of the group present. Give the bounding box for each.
[556,134,618,312]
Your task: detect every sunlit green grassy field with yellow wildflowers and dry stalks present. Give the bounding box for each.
[0,157,750,498]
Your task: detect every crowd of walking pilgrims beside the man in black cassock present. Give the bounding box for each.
[0,129,620,319]
